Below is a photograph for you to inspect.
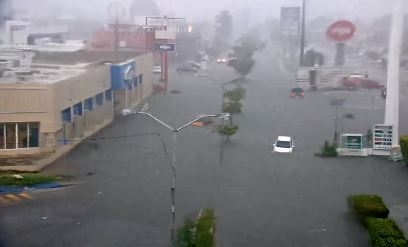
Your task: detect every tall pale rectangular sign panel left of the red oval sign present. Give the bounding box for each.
[280,7,301,36]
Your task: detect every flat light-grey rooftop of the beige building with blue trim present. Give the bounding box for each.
[0,50,146,84]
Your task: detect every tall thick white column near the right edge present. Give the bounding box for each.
[384,0,403,147]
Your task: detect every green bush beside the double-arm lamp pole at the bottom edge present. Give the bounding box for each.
[177,209,215,247]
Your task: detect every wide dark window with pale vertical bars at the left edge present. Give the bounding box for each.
[0,123,40,150]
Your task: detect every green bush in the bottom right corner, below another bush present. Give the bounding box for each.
[366,218,408,247]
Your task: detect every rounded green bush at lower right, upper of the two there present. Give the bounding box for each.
[348,195,390,223]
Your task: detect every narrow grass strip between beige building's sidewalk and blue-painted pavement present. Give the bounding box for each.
[0,174,57,186]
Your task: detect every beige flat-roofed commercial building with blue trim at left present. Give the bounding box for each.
[0,51,152,157]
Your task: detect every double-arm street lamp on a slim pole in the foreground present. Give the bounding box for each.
[122,107,230,247]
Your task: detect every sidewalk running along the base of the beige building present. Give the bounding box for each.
[0,121,113,172]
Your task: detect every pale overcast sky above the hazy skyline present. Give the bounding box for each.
[14,0,407,21]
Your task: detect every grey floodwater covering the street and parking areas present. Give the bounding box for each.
[0,44,408,247]
